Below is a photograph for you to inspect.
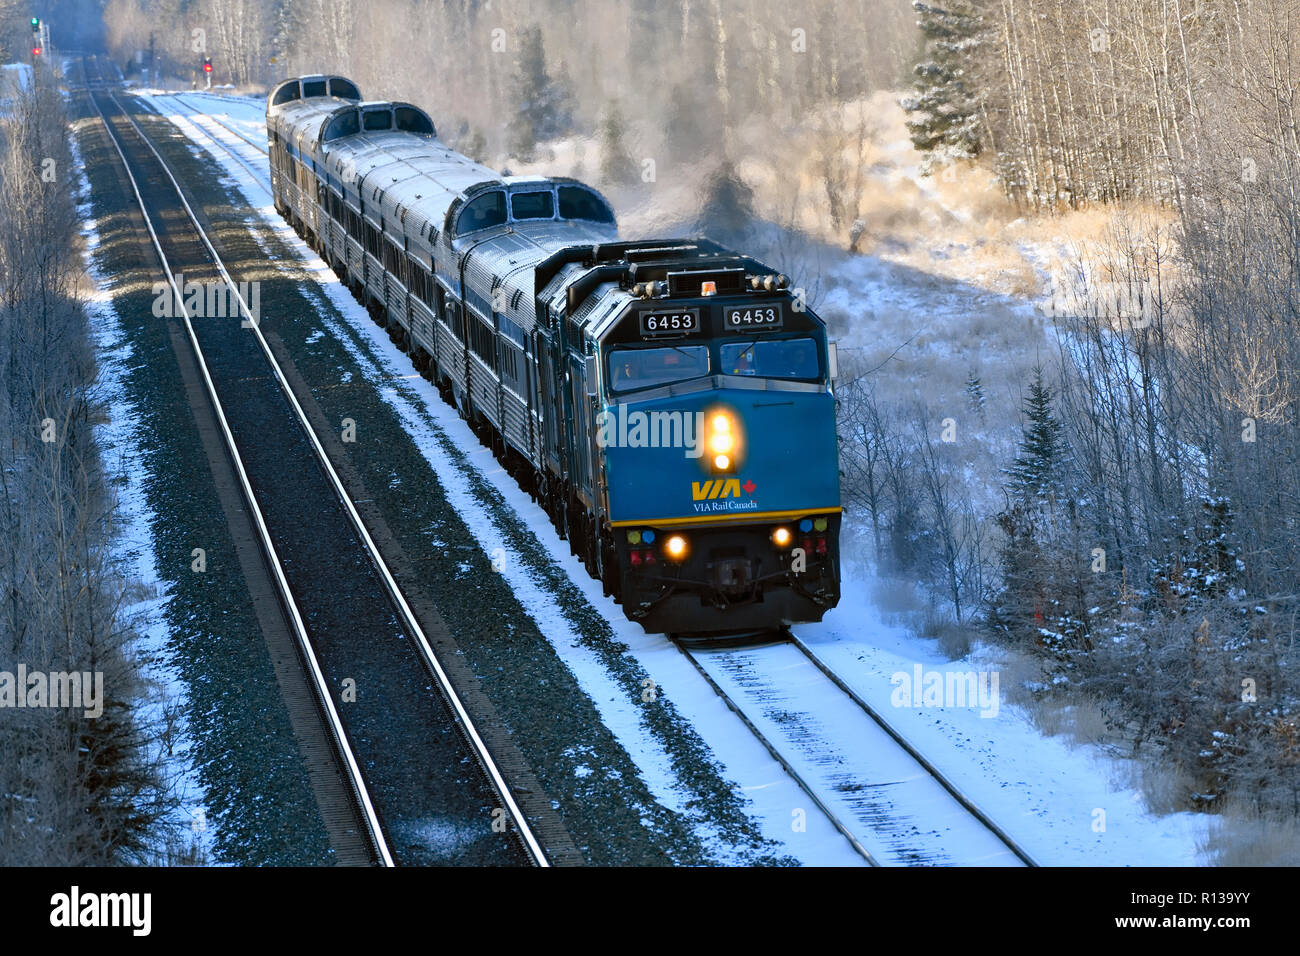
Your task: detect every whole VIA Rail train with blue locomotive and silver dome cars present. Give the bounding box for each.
[267,74,842,640]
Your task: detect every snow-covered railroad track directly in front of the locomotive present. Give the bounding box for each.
[677,633,1036,866]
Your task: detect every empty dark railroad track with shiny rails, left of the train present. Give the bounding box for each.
[82,60,550,866]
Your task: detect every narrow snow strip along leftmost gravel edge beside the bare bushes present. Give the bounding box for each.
[70,123,217,861]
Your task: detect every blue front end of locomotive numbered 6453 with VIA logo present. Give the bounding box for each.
[593,254,840,633]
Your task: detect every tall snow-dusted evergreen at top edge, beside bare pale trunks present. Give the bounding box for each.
[904,0,984,157]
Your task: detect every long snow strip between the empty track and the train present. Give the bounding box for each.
[142,96,863,866]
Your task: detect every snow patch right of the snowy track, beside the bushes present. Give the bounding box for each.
[796,556,1212,866]
